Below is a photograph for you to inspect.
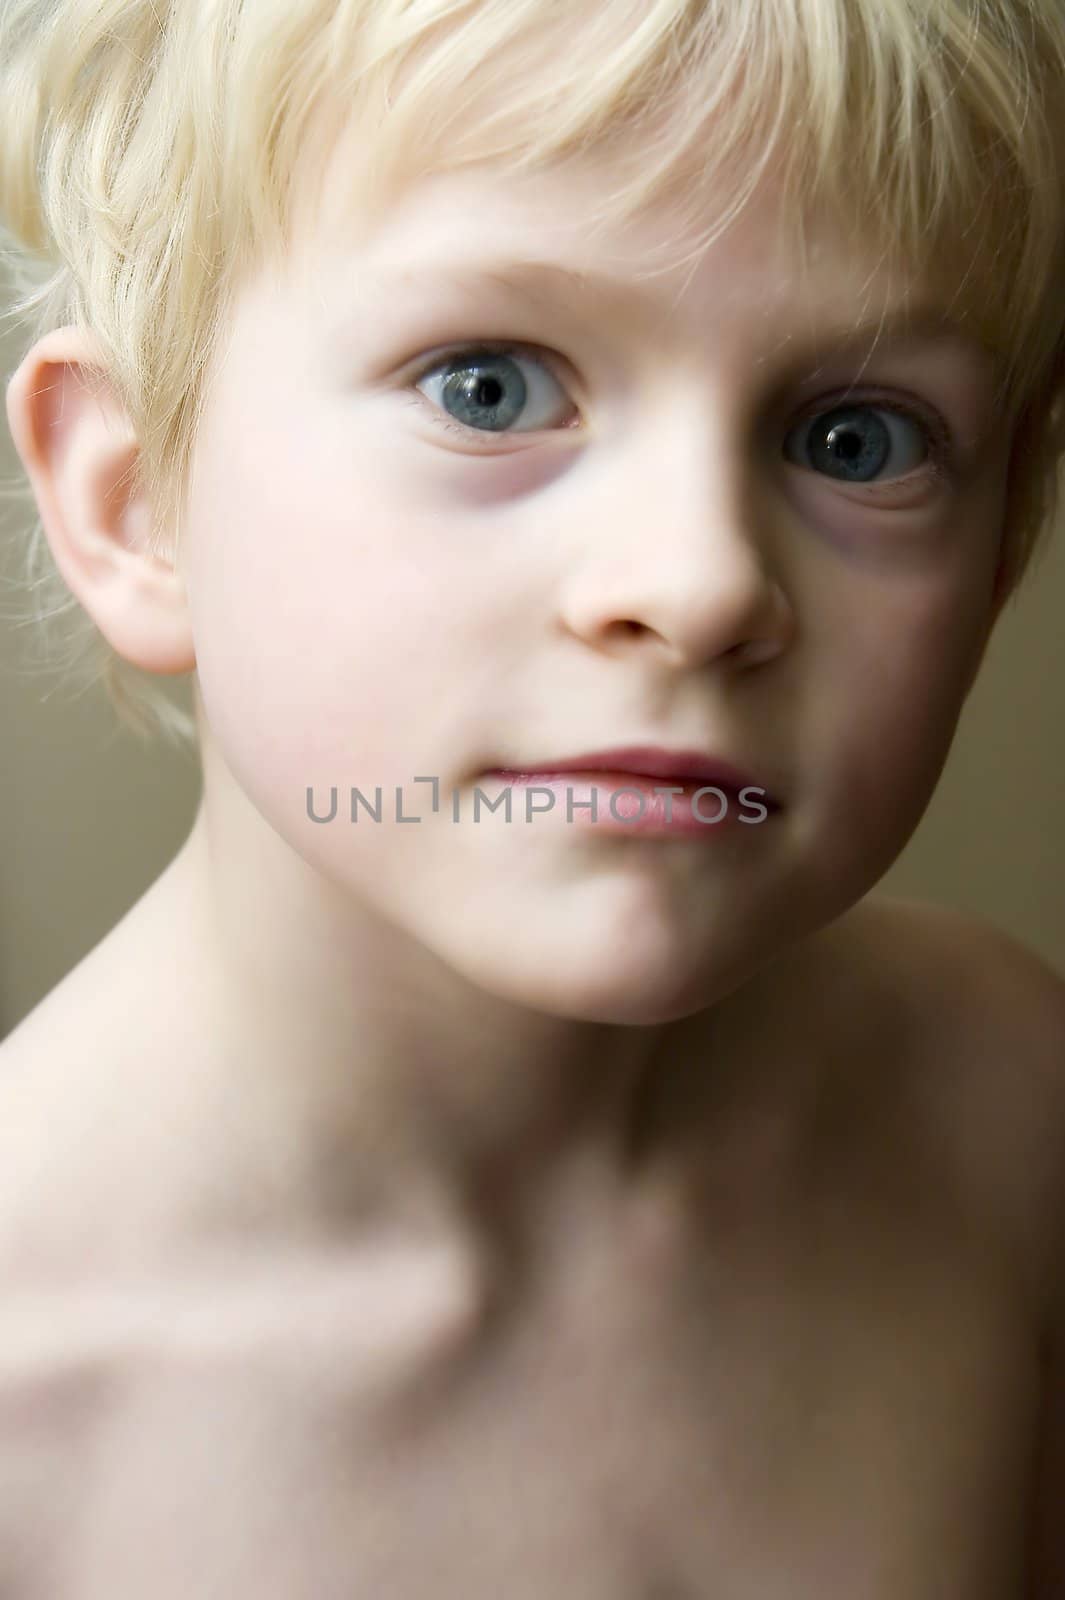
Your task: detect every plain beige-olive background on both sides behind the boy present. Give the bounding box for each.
[0,312,1065,1037]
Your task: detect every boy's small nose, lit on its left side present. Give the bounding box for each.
[561,434,795,666]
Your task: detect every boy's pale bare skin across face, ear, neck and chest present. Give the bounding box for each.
[0,131,1065,1600]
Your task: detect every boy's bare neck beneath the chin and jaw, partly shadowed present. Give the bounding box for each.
[165,802,705,1267]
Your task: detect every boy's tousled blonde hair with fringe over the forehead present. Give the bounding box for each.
[0,0,1065,741]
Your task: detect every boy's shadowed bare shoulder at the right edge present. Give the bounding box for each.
[838,898,1065,1306]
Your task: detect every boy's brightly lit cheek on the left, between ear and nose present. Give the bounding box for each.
[181,460,440,808]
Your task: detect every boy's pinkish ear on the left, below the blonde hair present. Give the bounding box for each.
[8,328,195,675]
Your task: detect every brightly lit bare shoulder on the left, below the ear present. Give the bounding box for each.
[0,925,211,1291]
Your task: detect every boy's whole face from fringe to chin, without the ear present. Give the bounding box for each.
[182,144,1011,1022]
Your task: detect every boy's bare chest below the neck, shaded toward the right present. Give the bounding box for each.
[3,1213,1036,1600]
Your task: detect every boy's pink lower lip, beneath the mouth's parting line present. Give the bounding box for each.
[476,771,777,840]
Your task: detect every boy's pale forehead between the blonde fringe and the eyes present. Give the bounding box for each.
[284,127,995,377]
